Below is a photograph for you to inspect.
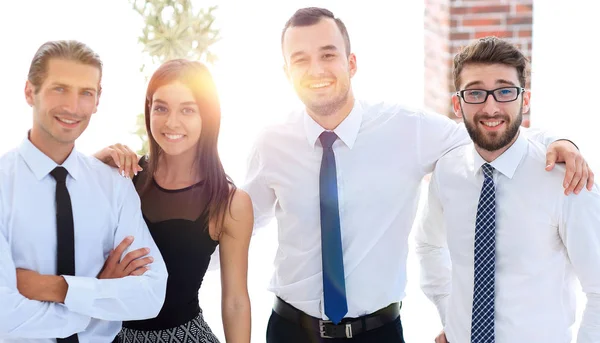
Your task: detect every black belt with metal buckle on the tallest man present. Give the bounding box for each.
[273,297,400,338]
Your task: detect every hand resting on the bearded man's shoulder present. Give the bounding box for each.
[546,140,594,195]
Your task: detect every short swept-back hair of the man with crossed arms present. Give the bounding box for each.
[27,40,102,94]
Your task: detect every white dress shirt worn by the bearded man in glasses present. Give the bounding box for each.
[416,133,600,343]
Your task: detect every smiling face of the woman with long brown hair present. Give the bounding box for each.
[150,81,202,156]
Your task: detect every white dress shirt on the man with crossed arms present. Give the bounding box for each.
[0,139,167,343]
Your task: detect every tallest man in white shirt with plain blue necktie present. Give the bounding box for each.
[244,8,588,343]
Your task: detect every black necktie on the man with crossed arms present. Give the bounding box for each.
[50,167,79,343]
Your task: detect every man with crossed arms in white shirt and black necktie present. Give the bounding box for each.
[0,41,167,343]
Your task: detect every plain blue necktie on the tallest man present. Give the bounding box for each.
[319,131,348,324]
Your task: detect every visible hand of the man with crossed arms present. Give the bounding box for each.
[98,236,154,279]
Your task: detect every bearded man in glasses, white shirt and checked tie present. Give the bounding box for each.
[417,37,600,343]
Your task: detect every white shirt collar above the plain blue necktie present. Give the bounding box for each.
[304,101,363,149]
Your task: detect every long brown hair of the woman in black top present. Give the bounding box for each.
[141,59,236,232]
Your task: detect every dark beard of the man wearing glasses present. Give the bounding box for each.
[461,104,523,151]
